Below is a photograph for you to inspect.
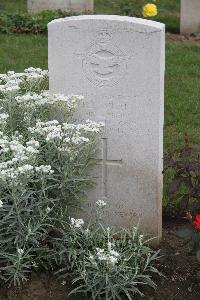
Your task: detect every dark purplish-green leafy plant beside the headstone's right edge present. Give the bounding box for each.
[164,135,200,213]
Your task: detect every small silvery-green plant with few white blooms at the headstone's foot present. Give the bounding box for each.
[54,200,161,300]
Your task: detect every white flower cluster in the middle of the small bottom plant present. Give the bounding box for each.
[89,242,120,265]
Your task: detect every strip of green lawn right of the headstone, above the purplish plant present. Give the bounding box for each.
[165,42,200,149]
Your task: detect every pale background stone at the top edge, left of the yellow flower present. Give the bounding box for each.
[27,0,93,13]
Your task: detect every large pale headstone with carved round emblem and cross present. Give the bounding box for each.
[48,16,165,240]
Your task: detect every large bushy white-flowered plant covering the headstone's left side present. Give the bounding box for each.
[0,68,102,285]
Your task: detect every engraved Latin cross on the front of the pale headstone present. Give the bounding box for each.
[97,138,122,198]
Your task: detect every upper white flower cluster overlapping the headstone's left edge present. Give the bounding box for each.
[15,91,82,111]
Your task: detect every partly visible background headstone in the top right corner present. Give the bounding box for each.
[180,0,200,34]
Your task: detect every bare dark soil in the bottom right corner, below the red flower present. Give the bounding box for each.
[144,223,200,300]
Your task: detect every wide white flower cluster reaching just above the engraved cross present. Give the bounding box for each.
[28,120,103,152]
